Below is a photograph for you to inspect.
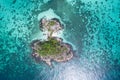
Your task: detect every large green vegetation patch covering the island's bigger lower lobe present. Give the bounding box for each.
[37,38,67,56]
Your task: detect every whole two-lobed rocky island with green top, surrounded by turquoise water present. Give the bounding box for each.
[31,18,73,65]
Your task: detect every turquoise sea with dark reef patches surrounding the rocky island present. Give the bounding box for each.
[0,0,120,80]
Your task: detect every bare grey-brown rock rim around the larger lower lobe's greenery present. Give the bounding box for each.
[31,37,73,65]
